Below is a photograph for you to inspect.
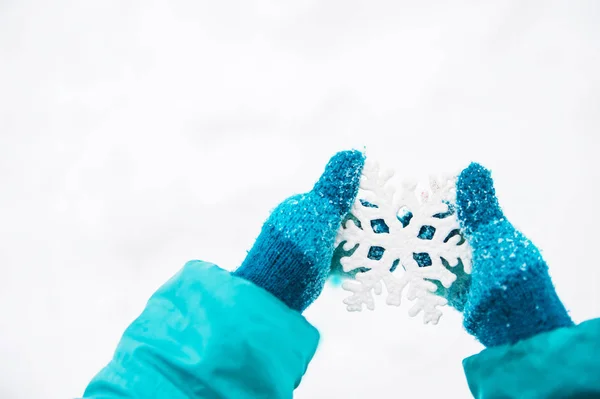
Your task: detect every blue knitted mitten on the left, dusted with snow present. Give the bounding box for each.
[234,151,365,312]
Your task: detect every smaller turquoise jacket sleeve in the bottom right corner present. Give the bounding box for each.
[463,319,600,399]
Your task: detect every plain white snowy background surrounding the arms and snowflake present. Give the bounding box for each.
[0,0,600,399]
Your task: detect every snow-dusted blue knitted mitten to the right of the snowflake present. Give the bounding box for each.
[450,164,573,347]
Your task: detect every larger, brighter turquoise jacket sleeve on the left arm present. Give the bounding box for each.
[84,261,319,399]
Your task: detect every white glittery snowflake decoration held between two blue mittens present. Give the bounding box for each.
[336,160,471,324]
